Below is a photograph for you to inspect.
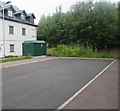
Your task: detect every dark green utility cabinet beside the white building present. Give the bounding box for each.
[22,40,46,56]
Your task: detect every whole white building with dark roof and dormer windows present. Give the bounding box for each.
[0,1,37,57]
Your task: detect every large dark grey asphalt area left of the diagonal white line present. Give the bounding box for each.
[2,59,112,109]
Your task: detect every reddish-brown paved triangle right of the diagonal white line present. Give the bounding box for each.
[64,61,118,111]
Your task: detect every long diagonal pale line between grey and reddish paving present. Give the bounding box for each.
[55,60,117,111]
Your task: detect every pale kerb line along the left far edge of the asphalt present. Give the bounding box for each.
[0,58,57,68]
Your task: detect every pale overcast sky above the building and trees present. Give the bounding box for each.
[1,0,118,24]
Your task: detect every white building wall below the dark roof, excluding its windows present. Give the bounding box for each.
[0,19,37,57]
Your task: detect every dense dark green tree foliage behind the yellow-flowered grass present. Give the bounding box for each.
[37,2,119,50]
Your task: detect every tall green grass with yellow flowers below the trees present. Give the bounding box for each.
[47,44,117,58]
